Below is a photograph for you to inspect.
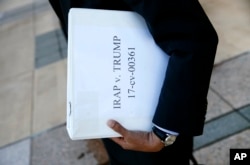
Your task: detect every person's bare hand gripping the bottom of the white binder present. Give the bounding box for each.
[107,120,164,152]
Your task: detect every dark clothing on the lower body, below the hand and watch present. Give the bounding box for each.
[103,136,193,165]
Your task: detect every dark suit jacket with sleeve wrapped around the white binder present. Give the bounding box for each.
[49,0,218,136]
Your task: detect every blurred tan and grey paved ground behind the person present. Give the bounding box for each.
[0,0,250,165]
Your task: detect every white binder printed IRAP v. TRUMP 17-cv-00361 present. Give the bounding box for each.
[67,8,169,140]
